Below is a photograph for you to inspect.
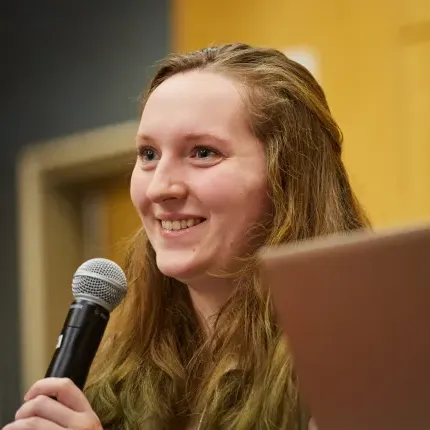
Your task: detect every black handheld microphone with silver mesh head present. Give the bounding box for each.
[45,258,127,390]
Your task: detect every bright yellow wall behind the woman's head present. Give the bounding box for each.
[172,0,430,225]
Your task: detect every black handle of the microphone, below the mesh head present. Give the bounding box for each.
[45,299,109,390]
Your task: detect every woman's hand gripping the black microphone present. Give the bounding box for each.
[3,378,102,430]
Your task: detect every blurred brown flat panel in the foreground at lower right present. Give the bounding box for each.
[262,225,430,430]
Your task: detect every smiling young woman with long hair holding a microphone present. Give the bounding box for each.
[6,44,367,430]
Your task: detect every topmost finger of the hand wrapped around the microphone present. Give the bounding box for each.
[24,378,92,412]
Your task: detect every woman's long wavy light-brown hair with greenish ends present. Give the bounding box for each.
[85,44,368,430]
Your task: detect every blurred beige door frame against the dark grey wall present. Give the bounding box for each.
[17,121,137,393]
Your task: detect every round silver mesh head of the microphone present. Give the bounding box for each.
[72,258,127,312]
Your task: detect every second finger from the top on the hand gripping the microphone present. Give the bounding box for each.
[15,395,76,428]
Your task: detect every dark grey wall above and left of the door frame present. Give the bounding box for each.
[0,0,170,426]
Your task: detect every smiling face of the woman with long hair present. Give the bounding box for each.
[131,71,270,284]
